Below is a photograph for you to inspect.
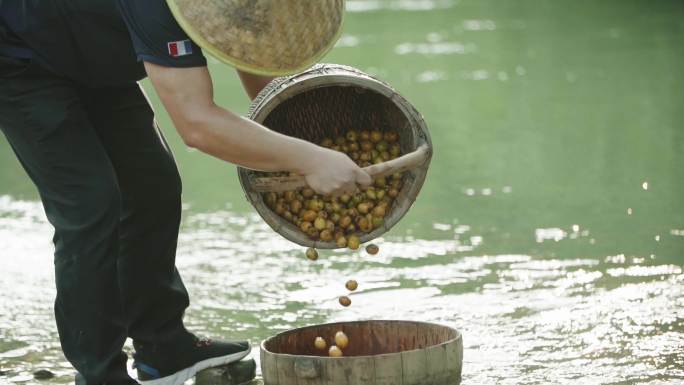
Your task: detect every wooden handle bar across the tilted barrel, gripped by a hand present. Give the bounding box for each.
[252,145,430,192]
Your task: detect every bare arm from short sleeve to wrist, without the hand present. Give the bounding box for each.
[145,62,312,172]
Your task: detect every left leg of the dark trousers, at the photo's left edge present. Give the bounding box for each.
[0,60,128,384]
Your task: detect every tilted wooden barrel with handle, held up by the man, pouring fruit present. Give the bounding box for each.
[238,64,432,249]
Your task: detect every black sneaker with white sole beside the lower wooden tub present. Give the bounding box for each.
[133,333,251,385]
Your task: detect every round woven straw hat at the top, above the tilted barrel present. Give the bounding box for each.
[166,0,344,76]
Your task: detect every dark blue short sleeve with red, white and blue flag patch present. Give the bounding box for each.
[117,0,207,67]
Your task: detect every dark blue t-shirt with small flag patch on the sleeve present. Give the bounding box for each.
[0,0,206,87]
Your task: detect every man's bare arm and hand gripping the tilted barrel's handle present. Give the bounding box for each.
[145,62,371,194]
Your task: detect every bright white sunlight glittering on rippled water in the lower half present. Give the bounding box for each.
[0,197,684,384]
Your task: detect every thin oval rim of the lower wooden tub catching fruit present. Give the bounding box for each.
[259,319,463,360]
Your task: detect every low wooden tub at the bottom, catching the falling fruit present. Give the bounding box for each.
[261,321,463,385]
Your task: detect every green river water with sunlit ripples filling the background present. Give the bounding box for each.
[0,0,684,384]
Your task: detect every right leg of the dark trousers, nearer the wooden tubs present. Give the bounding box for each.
[83,84,189,343]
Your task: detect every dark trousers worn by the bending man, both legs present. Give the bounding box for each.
[0,57,189,384]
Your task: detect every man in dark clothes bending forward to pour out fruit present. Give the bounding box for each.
[0,0,370,385]
